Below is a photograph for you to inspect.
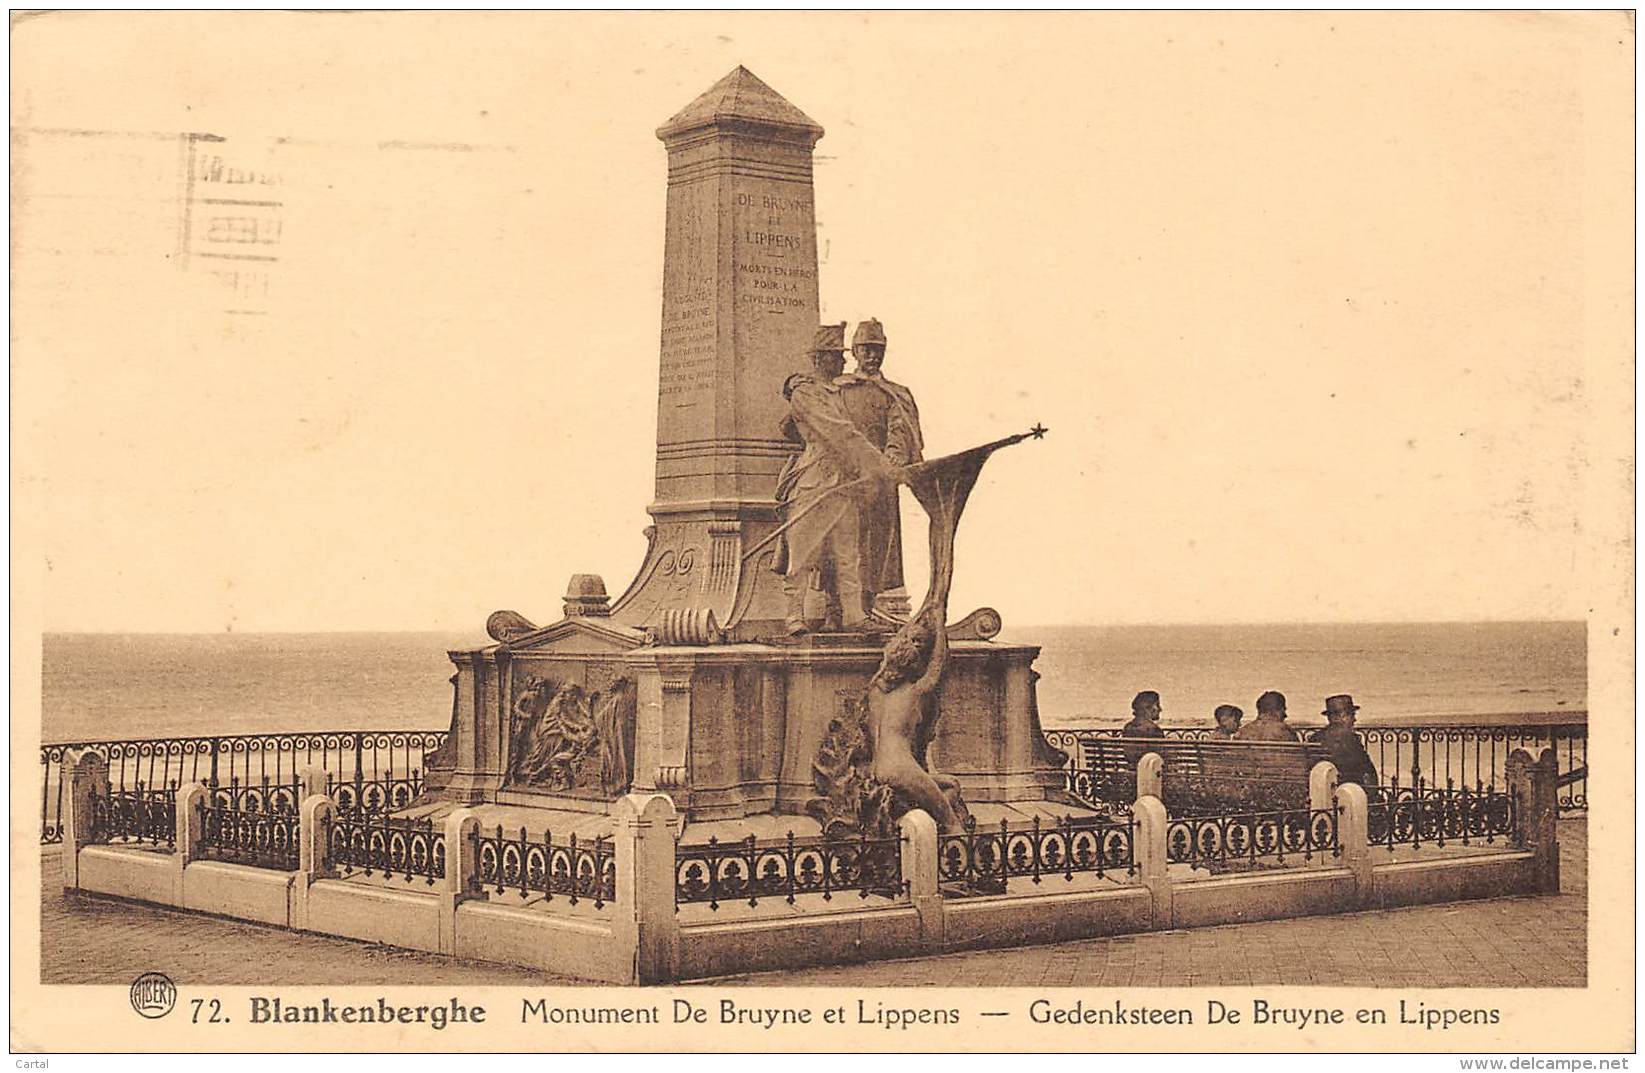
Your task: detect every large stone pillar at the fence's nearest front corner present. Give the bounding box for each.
[612,793,679,984]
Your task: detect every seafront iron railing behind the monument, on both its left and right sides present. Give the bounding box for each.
[39,713,1587,843]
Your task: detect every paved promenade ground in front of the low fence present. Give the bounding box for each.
[41,820,1587,987]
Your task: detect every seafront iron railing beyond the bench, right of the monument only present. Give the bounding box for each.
[1045,713,1587,811]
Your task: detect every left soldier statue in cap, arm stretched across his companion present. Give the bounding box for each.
[776,323,895,637]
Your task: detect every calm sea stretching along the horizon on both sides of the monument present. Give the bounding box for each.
[43,622,1587,741]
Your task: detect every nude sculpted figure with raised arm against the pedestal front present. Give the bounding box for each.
[864,609,969,833]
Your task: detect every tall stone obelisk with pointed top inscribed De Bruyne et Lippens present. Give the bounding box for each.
[612,67,823,643]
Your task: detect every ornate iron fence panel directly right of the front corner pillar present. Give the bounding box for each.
[674,831,908,910]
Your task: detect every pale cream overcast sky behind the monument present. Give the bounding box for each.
[13,13,1633,630]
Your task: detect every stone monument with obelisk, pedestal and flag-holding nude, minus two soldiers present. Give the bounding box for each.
[424,67,1081,839]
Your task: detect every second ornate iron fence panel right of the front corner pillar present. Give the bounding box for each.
[938,816,1137,897]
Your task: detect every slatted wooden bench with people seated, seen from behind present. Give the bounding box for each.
[1082,737,1328,815]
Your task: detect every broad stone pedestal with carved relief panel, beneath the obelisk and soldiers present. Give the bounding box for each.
[434,619,1068,821]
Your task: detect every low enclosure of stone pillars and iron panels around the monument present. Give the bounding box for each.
[54,749,1559,984]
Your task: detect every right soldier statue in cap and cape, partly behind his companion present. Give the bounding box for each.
[836,318,924,609]
